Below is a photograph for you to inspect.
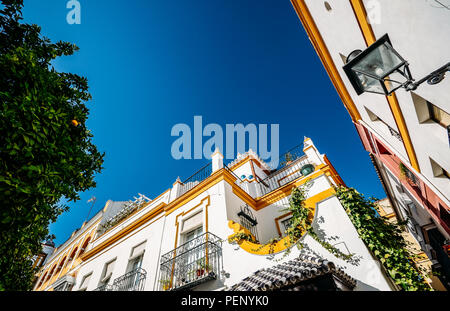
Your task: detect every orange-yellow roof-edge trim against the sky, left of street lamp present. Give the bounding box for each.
[291,0,361,122]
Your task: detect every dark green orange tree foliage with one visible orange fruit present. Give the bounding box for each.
[0,0,104,290]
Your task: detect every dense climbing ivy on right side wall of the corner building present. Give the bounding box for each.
[335,186,431,291]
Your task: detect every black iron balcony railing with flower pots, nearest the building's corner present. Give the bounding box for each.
[159,232,222,290]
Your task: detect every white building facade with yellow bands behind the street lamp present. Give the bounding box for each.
[291,0,450,289]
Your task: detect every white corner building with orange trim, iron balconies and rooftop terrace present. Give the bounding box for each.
[34,138,395,291]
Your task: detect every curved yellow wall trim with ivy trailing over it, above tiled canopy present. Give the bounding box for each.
[228,188,335,255]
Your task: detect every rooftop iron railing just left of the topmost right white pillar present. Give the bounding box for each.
[258,155,311,196]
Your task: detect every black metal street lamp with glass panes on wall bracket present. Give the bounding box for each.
[343,34,450,95]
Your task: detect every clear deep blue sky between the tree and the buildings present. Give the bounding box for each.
[24,0,385,245]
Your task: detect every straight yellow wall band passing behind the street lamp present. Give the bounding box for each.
[350,0,420,173]
